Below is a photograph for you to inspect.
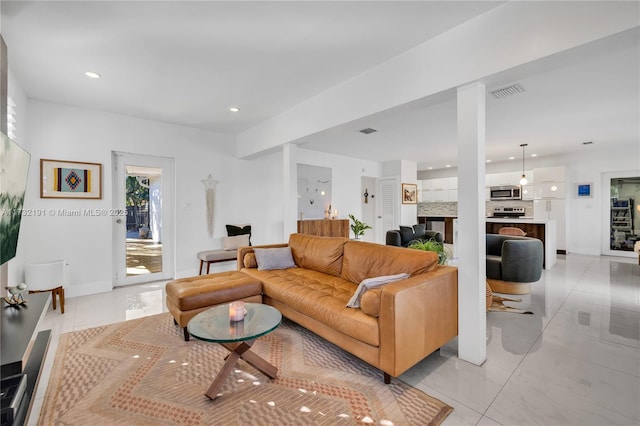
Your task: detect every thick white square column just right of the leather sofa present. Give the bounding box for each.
[456,83,487,365]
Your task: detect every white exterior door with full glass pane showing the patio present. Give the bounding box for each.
[113,152,174,286]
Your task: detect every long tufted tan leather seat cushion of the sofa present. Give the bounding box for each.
[243,268,380,346]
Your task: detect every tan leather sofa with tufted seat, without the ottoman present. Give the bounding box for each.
[238,234,458,383]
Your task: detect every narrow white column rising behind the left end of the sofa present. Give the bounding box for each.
[282,143,298,242]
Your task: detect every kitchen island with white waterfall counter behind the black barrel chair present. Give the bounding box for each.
[486,217,558,269]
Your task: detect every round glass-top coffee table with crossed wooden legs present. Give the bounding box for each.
[187,303,282,399]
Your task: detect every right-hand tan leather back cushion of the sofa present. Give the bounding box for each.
[341,241,438,283]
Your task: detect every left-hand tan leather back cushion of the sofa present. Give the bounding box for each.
[289,234,348,276]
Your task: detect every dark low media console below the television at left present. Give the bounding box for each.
[0,293,51,425]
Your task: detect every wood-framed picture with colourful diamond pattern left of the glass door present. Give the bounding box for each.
[40,158,102,199]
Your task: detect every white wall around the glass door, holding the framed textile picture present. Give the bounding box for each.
[20,100,280,296]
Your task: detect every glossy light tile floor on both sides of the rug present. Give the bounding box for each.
[29,255,640,426]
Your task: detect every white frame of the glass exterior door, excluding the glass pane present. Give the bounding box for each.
[112,151,175,287]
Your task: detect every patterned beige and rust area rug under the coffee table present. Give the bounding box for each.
[38,313,453,425]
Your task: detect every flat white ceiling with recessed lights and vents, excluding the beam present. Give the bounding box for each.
[0,1,640,169]
